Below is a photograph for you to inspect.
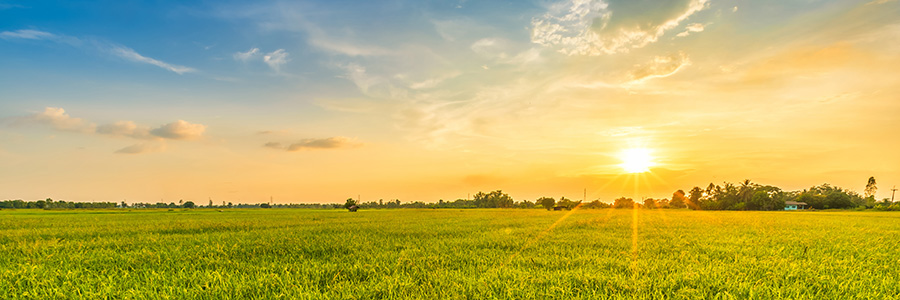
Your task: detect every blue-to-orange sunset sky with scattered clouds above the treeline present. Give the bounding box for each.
[0,0,900,204]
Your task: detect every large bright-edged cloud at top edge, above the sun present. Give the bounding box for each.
[531,0,708,55]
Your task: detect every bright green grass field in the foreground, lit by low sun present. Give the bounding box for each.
[0,209,900,299]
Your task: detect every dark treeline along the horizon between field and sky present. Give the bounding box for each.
[0,178,900,211]
